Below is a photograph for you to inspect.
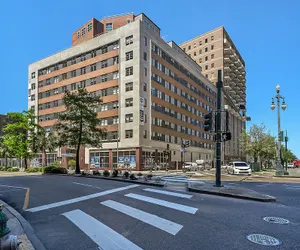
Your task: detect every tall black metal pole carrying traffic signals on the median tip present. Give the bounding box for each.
[215,69,223,187]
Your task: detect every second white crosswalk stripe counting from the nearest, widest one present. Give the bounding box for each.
[101,200,183,235]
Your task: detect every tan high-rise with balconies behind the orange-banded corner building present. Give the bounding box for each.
[180,27,246,163]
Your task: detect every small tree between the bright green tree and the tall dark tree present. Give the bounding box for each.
[35,126,57,166]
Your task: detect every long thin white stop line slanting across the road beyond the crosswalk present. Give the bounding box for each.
[26,184,139,213]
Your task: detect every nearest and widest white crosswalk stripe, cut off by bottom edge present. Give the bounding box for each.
[63,209,142,250]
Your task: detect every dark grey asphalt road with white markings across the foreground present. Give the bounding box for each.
[0,176,300,250]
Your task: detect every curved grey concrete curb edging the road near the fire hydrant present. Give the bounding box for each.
[0,200,46,250]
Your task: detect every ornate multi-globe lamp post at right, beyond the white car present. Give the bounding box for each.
[270,85,287,175]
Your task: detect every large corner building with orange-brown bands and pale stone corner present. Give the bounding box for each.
[28,14,216,169]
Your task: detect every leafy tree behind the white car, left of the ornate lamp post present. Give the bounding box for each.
[240,124,276,166]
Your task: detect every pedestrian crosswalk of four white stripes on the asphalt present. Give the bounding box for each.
[63,188,198,250]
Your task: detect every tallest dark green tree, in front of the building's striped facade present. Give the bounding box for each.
[56,88,105,174]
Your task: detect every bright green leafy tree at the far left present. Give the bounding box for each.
[3,110,38,169]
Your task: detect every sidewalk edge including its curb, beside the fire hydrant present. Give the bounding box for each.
[0,200,45,250]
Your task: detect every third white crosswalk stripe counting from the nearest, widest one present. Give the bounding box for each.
[125,193,198,214]
